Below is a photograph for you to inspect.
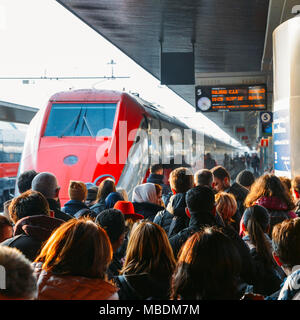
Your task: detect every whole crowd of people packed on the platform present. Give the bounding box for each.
[0,164,300,300]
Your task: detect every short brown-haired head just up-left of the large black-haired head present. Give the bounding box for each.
[169,167,194,194]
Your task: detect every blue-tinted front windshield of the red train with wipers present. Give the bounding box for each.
[44,103,117,138]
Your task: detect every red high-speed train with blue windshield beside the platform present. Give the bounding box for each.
[19,89,236,204]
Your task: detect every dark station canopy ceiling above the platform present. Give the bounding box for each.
[57,0,299,147]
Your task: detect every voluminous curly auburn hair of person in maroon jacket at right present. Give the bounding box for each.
[245,173,295,210]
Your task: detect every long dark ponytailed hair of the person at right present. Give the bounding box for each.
[243,205,276,266]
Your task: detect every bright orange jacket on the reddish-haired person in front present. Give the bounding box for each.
[33,262,118,300]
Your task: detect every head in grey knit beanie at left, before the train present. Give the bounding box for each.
[31,172,60,200]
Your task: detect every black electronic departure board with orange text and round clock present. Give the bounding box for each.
[196,84,267,112]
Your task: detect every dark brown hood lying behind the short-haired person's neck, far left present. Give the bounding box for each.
[14,215,65,241]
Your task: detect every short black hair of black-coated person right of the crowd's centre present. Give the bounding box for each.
[185,186,215,213]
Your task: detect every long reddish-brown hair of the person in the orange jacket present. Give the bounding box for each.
[35,218,113,279]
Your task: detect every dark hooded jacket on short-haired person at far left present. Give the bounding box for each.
[1,215,65,261]
